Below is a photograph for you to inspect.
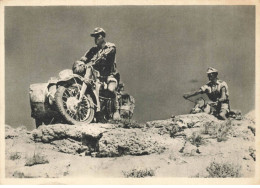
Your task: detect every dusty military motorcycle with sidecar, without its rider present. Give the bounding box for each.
[30,58,135,128]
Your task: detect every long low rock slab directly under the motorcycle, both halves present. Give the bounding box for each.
[31,124,168,157]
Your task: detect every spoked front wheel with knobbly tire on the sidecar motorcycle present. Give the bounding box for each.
[55,84,95,124]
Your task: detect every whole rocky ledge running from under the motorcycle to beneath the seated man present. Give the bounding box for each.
[6,111,254,157]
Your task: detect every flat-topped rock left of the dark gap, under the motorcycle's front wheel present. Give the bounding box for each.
[31,124,116,154]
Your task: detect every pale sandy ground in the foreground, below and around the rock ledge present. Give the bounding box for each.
[5,112,255,178]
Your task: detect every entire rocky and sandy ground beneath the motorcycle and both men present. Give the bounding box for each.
[5,110,256,178]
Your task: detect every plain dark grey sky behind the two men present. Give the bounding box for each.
[5,6,255,129]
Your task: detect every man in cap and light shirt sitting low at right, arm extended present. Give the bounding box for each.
[183,67,230,120]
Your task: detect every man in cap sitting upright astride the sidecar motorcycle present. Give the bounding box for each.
[73,27,120,120]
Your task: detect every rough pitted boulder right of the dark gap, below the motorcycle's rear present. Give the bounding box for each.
[97,128,166,157]
